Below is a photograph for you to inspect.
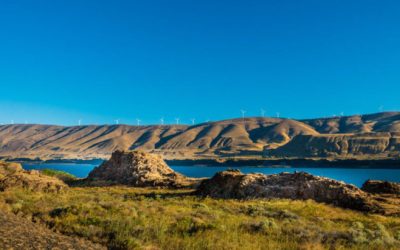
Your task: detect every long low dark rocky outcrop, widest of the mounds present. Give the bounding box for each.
[198,170,382,212]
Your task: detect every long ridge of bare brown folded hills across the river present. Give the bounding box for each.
[0,112,400,159]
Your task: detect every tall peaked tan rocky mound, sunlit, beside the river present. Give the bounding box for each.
[87,151,195,187]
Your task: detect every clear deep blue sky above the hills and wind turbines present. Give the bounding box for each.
[0,0,400,125]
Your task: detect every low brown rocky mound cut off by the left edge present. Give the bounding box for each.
[0,162,67,192]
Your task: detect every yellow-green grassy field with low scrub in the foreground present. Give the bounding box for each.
[0,187,400,249]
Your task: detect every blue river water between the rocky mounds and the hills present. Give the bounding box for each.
[23,163,400,187]
